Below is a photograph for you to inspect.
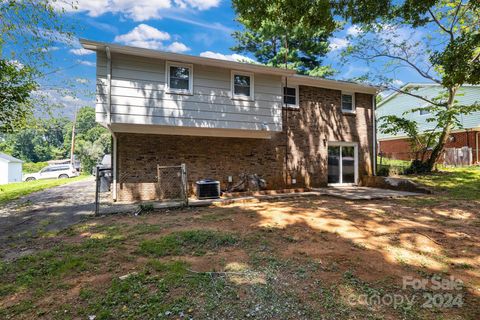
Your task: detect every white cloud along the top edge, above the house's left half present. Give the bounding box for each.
[55,0,220,21]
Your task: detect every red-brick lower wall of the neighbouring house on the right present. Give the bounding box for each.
[378,130,480,162]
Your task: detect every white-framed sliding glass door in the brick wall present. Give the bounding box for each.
[327,142,358,185]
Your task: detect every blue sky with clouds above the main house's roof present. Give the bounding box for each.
[39,0,422,114]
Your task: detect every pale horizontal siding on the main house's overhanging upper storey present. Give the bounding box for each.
[96,53,282,131]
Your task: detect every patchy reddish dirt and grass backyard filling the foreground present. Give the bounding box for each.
[0,197,480,319]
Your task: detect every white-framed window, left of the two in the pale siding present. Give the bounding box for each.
[166,62,193,94]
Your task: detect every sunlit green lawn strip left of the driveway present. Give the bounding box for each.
[0,175,89,203]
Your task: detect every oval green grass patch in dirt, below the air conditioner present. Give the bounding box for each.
[140,230,238,257]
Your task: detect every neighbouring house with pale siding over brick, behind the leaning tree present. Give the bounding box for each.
[376,83,480,163]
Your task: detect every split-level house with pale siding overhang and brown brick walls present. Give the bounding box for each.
[81,40,377,201]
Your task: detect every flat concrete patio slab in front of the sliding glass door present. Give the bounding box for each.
[312,186,424,200]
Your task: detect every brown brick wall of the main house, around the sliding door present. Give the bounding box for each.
[117,86,372,201]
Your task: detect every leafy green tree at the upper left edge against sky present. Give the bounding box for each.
[0,0,72,132]
